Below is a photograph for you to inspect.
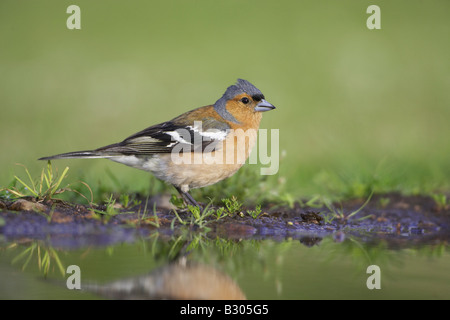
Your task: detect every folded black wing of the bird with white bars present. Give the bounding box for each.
[96,118,230,155]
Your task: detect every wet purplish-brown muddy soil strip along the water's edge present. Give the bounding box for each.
[0,193,450,248]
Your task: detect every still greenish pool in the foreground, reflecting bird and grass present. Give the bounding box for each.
[0,232,450,299]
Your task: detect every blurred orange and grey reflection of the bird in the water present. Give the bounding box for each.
[82,258,246,300]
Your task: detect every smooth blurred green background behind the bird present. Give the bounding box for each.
[0,0,450,197]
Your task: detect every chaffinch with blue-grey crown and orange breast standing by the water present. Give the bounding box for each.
[39,79,275,206]
